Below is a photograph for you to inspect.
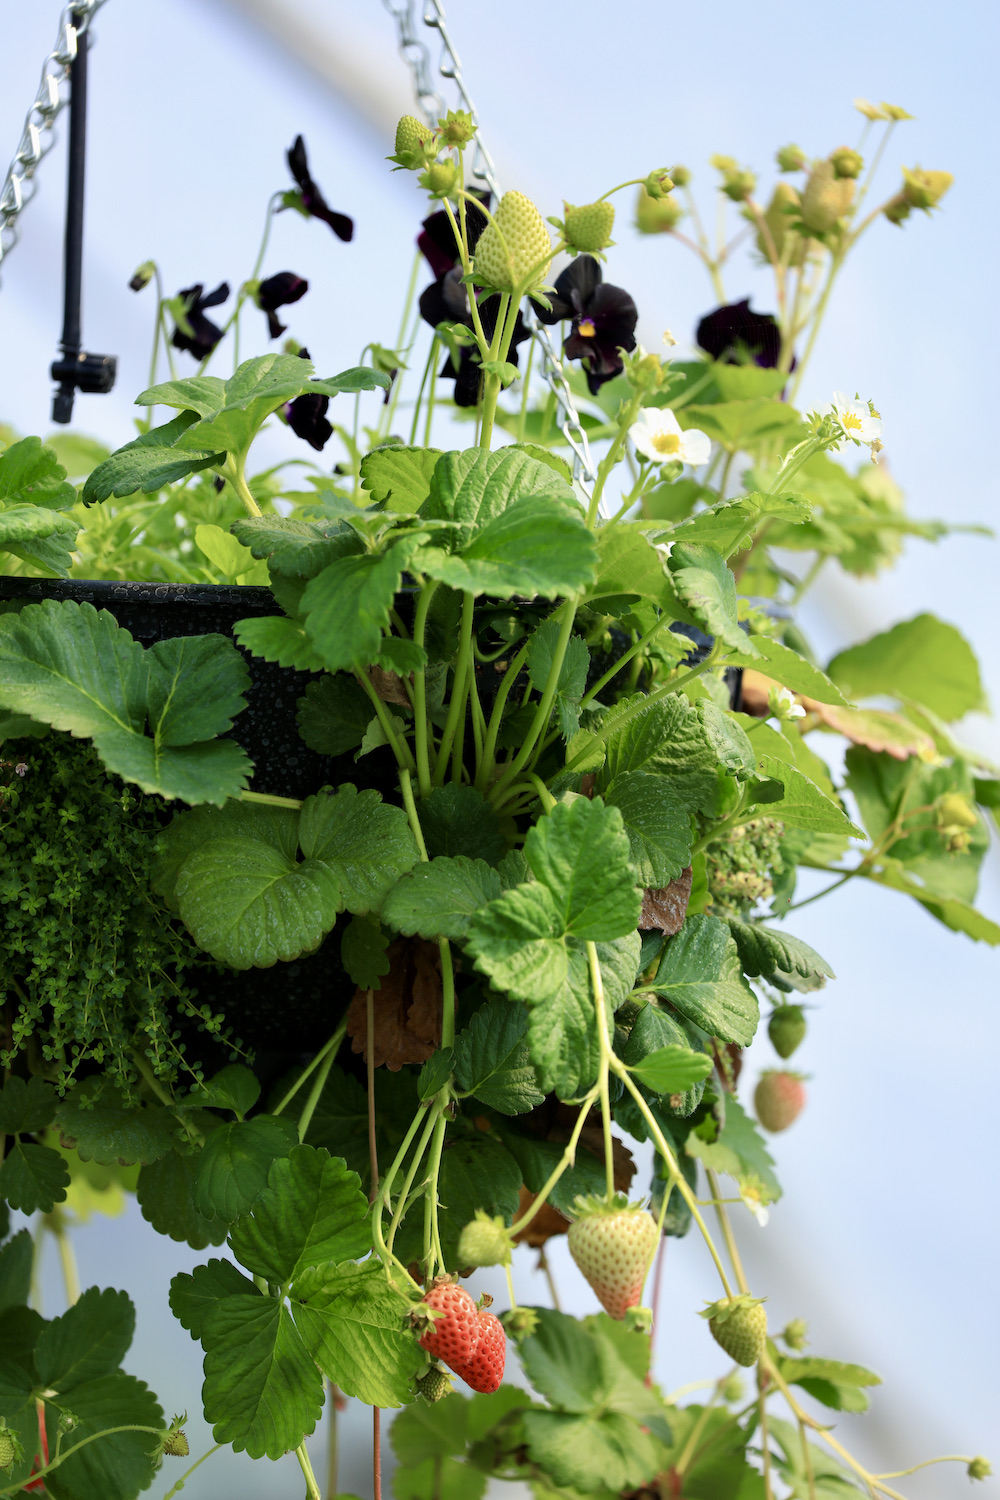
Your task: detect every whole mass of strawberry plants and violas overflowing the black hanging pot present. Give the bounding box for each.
[0,105,1000,1500]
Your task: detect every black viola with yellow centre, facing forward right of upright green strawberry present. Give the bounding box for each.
[535,255,639,396]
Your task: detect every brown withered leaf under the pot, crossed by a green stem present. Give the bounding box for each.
[348,938,444,1073]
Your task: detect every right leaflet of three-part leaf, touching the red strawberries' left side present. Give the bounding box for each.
[292,1260,424,1407]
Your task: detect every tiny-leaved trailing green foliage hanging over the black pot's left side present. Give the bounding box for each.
[0,734,229,1095]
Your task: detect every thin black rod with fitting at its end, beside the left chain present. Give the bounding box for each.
[49,12,118,425]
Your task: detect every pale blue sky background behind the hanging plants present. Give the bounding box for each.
[0,0,1000,1500]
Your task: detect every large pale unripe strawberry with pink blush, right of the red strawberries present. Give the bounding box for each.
[568,1193,658,1322]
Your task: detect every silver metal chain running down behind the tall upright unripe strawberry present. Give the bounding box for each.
[384,0,597,483]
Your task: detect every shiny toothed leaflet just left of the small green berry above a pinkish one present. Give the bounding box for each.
[652,915,760,1047]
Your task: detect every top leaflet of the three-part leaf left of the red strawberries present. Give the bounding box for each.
[229,1146,372,1286]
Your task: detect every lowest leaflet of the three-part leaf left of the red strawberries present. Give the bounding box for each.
[201,1295,324,1458]
